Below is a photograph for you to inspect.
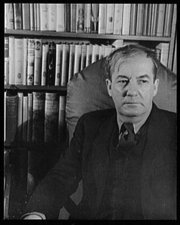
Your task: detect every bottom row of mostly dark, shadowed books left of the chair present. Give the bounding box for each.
[4,92,66,144]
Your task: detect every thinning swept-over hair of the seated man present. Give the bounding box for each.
[105,44,159,81]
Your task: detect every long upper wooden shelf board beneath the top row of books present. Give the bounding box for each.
[4,30,171,42]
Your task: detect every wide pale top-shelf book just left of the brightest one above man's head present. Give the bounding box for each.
[113,4,124,34]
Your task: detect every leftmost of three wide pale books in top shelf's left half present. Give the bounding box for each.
[40,4,48,31]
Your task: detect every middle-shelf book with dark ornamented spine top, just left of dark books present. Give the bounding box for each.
[34,39,42,85]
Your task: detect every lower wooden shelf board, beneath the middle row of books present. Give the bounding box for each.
[4,85,67,94]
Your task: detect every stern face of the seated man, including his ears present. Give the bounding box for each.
[106,55,159,117]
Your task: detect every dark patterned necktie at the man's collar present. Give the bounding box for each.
[118,123,136,148]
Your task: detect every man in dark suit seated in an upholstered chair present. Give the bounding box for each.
[21,45,177,220]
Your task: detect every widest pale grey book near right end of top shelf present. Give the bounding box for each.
[156,4,166,36]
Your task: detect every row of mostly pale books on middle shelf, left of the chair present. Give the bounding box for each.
[4,36,115,86]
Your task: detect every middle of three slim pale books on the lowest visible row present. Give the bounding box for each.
[22,96,28,143]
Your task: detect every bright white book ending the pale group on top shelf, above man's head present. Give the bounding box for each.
[122,3,131,35]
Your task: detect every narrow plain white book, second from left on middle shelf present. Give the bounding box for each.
[9,36,15,85]
